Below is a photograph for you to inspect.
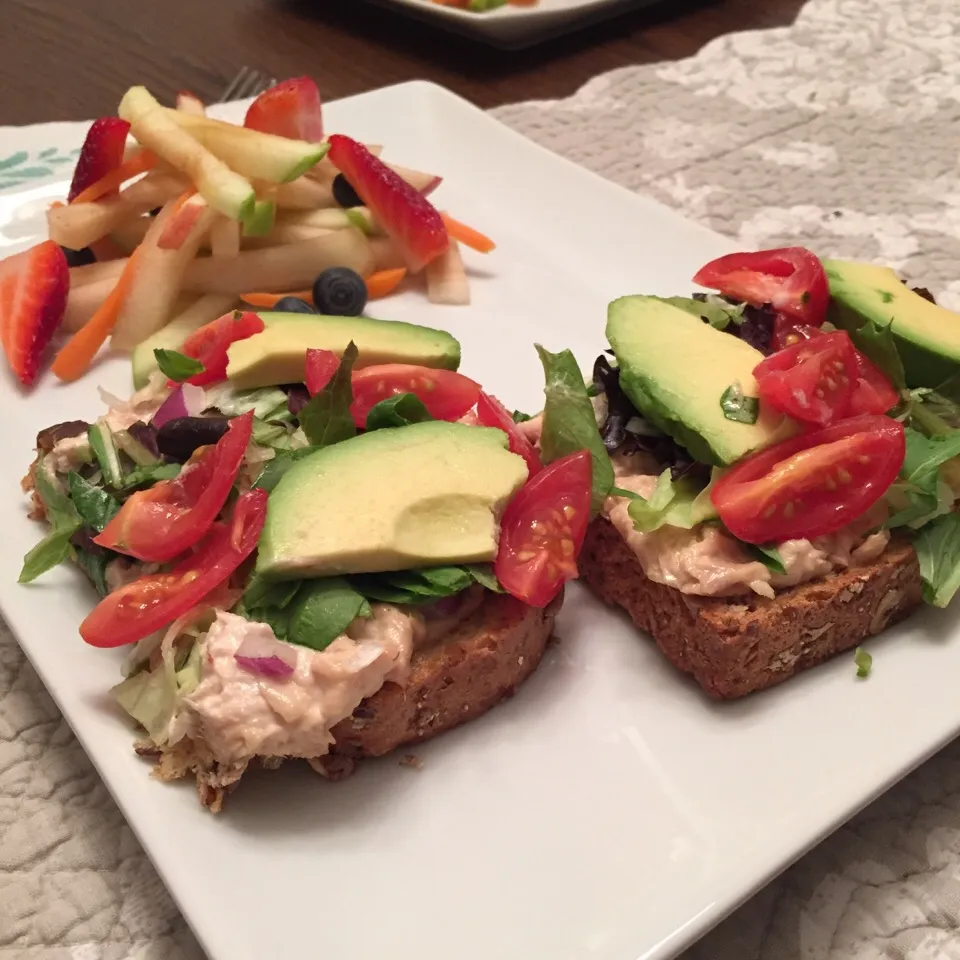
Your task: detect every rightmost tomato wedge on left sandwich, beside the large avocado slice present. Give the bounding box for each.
[493,450,592,607]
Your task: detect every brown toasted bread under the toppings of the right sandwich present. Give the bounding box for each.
[580,519,923,700]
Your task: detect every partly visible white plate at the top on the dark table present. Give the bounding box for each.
[362,0,656,49]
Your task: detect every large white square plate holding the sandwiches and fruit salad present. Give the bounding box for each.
[0,83,960,960]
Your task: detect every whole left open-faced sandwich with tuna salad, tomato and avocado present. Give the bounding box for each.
[21,313,595,810]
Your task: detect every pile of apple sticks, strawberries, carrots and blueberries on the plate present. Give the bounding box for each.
[0,77,494,386]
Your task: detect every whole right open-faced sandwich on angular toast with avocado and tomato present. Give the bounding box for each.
[529,248,960,698]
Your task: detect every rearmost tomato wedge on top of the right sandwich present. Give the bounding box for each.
[693,247,830,327]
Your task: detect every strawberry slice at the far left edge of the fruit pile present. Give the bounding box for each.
[0,240,70,386]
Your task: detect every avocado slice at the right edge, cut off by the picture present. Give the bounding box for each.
[823,260,960,387]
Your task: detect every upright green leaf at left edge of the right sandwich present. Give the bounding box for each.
[536,344,613,516]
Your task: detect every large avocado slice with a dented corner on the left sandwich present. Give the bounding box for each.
[257,420,527,580]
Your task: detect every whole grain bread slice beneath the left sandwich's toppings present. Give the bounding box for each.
[146,593,562,812]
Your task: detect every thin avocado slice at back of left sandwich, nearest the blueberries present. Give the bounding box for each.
[227,311,460,389]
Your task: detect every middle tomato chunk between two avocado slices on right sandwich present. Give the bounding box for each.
[753,331,860,425]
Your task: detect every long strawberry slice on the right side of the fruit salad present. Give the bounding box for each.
[328,133,450,273]
